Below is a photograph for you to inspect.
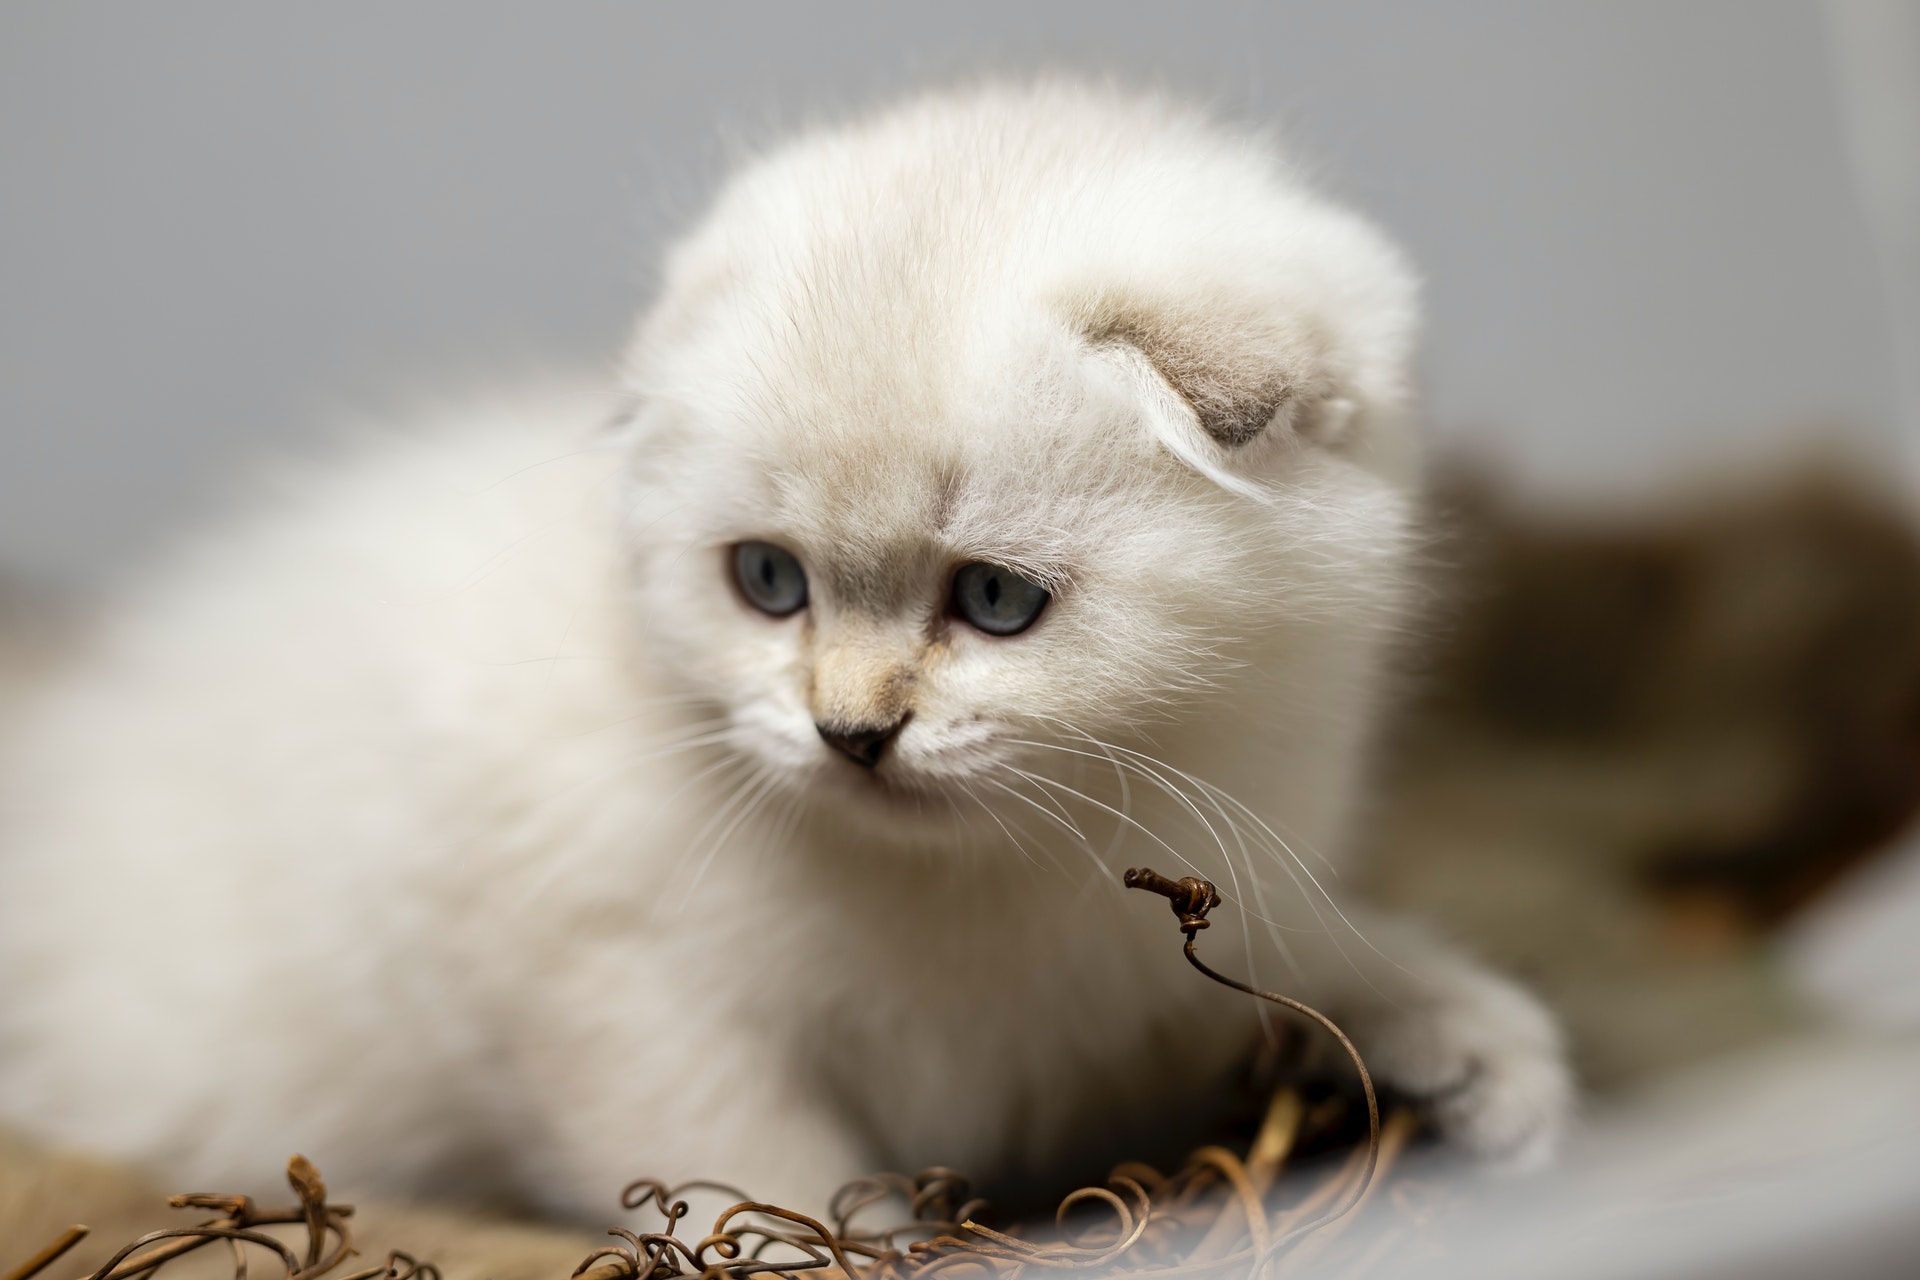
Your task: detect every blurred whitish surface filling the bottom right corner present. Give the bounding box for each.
[1305,1036,1920,1280]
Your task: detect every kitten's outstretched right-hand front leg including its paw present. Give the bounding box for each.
[1302,915,1574,1167]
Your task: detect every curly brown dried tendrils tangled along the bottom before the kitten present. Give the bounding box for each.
[0,869,1415,1280]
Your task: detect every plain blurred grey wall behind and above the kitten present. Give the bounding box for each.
[0,0,1920,581]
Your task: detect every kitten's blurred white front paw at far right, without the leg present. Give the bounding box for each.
[1356,973,1574,1169]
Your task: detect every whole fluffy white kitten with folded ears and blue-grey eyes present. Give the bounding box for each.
[0,84,1571,1217]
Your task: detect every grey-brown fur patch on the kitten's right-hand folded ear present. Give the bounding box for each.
[1087,315,1296,449]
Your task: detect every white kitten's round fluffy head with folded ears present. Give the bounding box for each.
[630,84,1413,852]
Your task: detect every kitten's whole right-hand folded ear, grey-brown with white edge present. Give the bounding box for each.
[1079,289,1405,493]
